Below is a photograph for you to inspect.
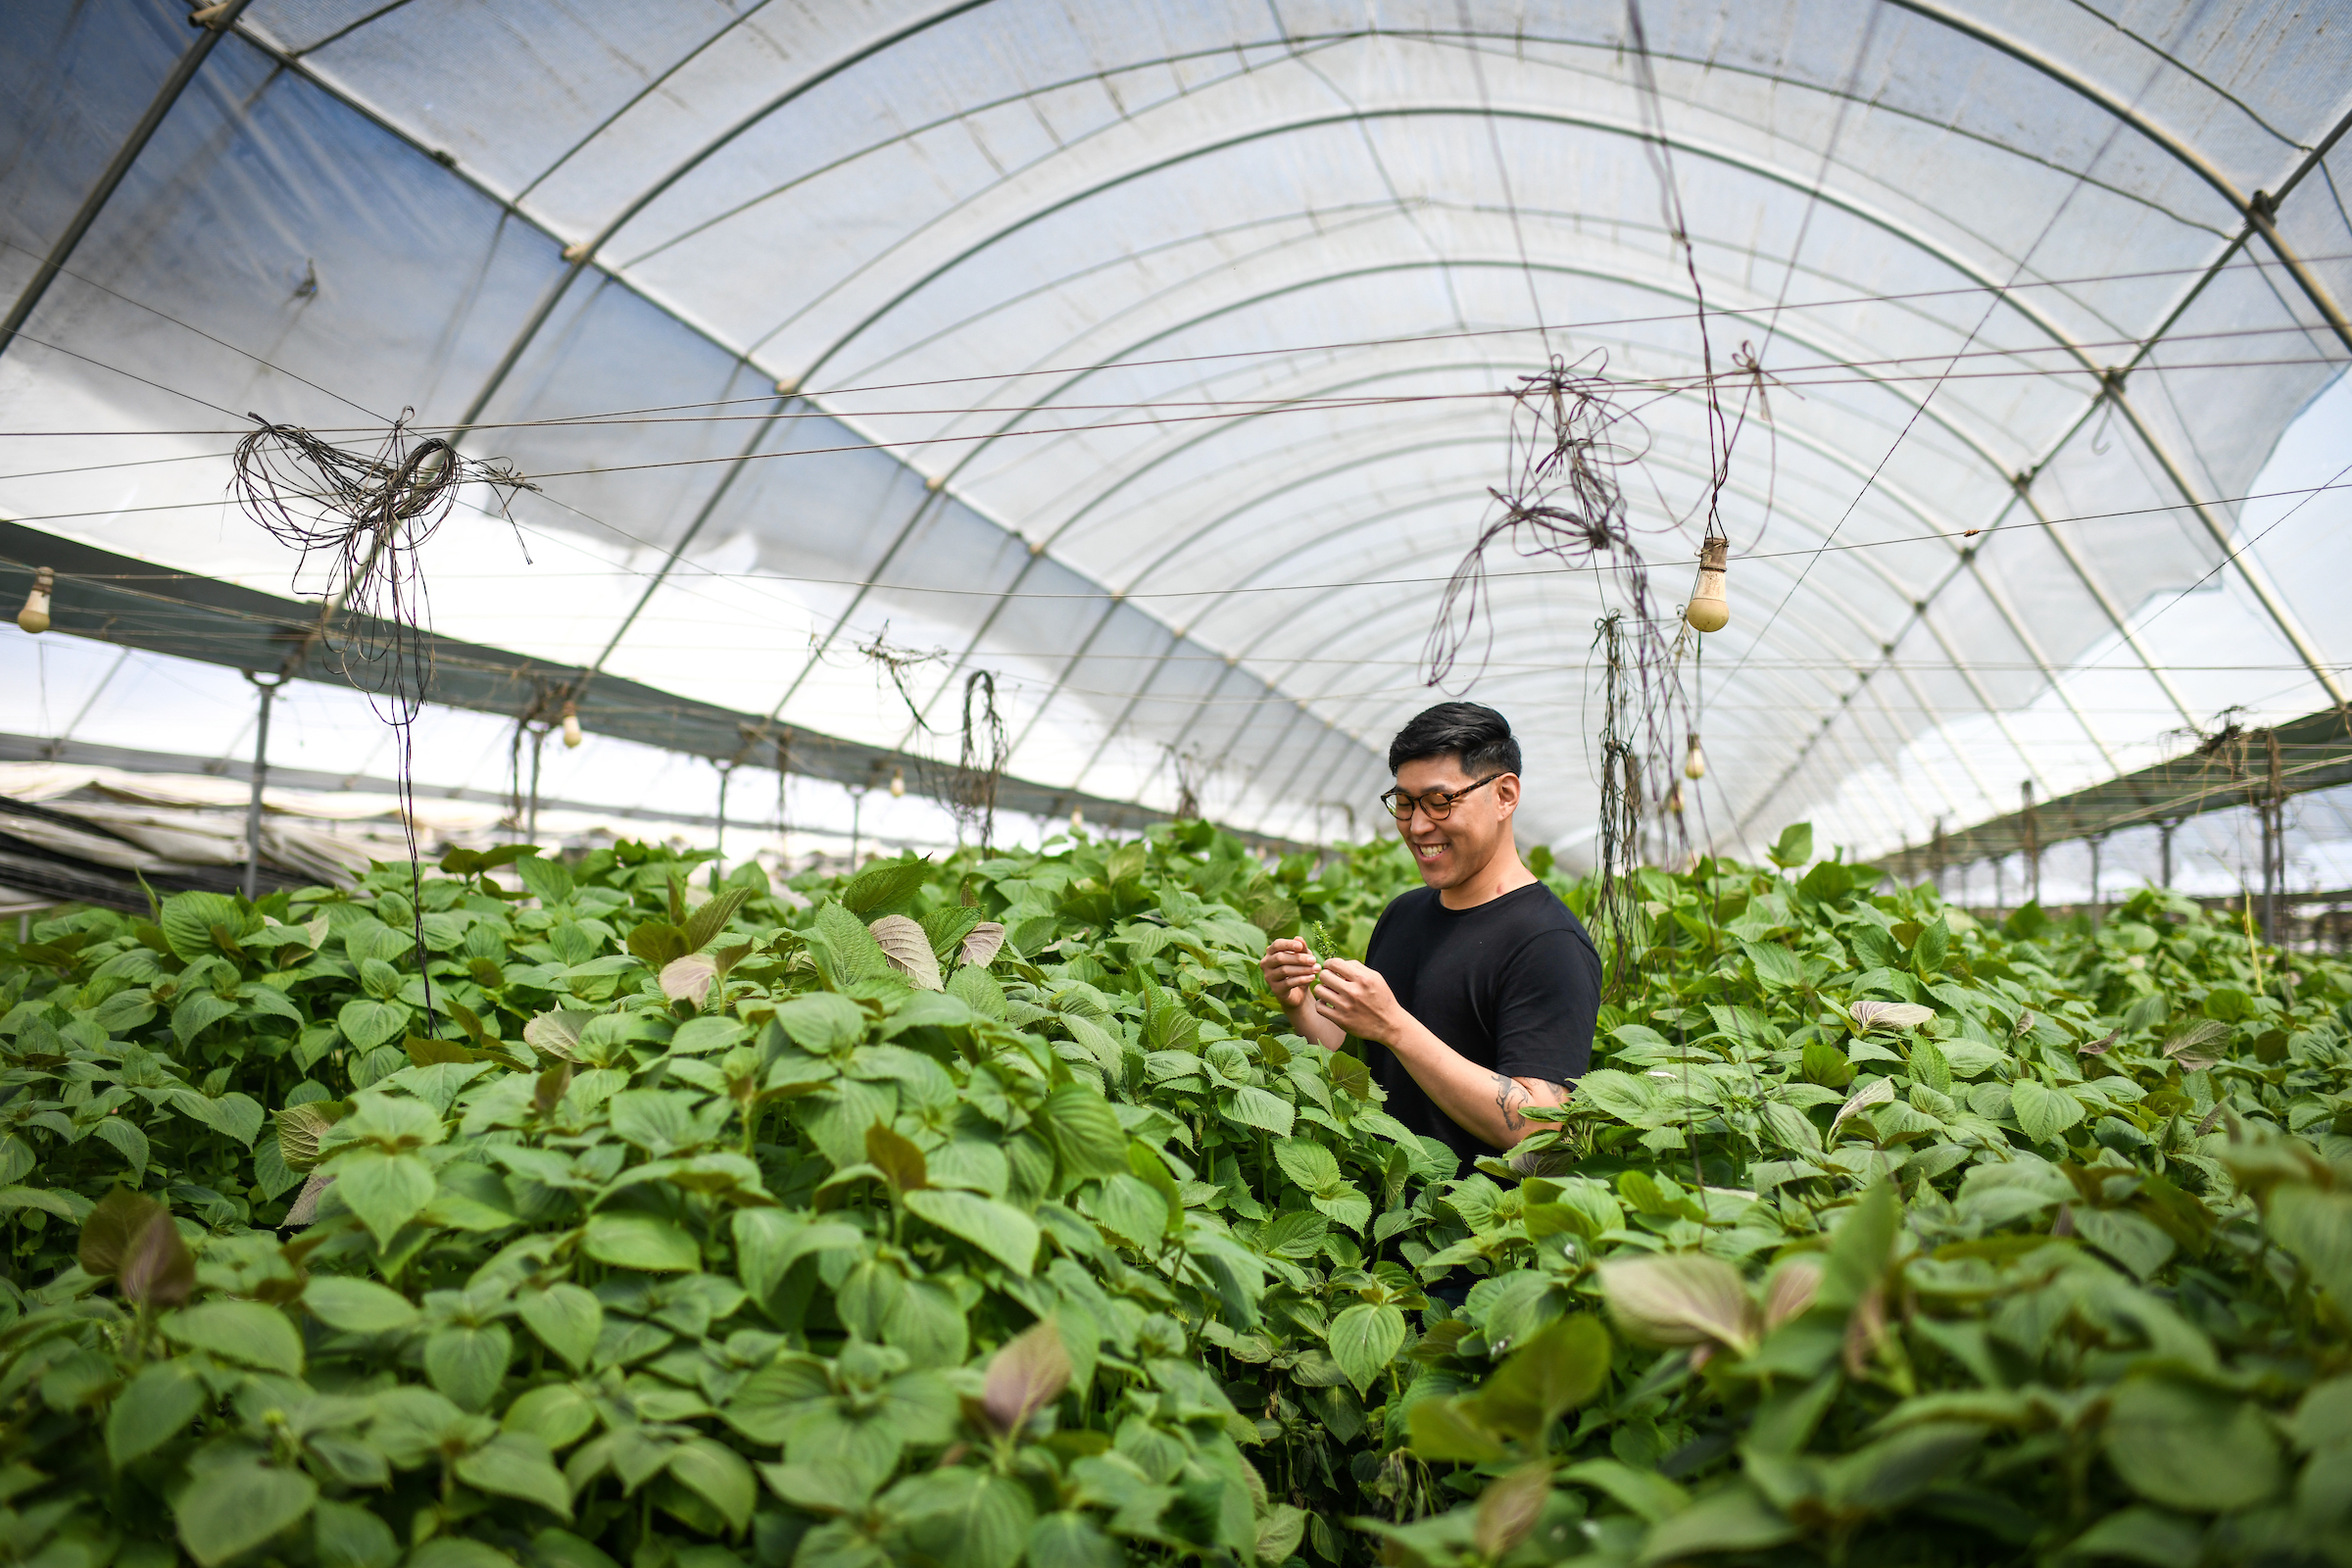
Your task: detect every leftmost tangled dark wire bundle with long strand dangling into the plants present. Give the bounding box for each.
[233,409,536,1018]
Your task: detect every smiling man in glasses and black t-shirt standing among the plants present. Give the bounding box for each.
[1263,703,1601,1173]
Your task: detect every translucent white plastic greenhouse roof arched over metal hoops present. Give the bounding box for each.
[0,0,2352,858]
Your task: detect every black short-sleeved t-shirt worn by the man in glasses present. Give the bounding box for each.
[1364,882,1601,1173]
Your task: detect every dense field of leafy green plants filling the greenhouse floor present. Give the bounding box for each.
[0,823,2352,1568]
